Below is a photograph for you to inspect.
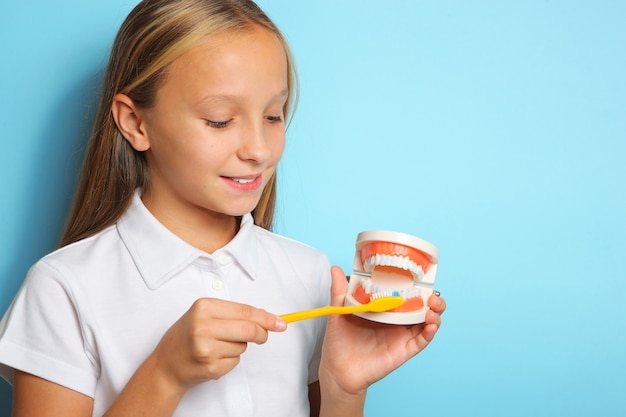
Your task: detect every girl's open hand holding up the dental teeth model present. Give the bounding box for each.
[320,267,446,398]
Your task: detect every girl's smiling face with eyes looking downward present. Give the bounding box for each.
[134,27,288,234]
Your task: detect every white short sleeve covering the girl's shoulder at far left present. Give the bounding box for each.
[0,261,99,397]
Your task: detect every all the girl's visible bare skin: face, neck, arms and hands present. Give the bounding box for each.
[13,24,445,417]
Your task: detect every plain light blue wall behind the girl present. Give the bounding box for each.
[0,0,626,416]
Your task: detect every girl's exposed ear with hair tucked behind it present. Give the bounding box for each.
[111,94,150,152]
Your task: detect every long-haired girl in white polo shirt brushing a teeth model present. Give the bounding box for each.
[0,0,445,417]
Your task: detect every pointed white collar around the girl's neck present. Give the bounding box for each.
[117,192,257,290]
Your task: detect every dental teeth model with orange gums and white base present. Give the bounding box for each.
[344,230,439,324]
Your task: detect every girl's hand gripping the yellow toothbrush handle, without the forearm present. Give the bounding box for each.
[152,298,287,391]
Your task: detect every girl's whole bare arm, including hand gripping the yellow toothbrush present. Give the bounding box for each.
[13,298,287,417]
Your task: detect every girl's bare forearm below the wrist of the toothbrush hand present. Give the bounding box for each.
[104,355,186,417]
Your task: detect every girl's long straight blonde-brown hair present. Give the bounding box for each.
[60,0,298,246]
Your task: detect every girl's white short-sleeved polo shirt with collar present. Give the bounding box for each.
[0,195,330,417]
